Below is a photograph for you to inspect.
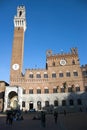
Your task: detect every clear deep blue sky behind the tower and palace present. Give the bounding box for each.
[0,0,87,83]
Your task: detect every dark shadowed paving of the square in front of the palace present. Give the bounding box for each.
[0,112,87,130]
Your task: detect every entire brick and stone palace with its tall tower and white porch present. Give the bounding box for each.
[0,6,87,111]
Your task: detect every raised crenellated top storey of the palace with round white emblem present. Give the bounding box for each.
[46,48,80,68]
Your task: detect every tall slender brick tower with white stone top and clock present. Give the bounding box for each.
[10,6,26,85]
